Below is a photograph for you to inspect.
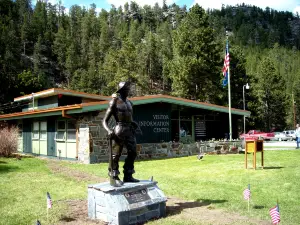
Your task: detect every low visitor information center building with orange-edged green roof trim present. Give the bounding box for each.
[0,88,250,163]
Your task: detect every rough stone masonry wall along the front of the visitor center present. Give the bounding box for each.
[78,111,242,164]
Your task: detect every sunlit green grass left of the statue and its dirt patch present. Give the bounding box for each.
[0,158,86,225]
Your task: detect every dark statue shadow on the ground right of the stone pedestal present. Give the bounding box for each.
[166,199,227,216]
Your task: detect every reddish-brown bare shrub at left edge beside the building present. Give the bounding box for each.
[0,127,18,157]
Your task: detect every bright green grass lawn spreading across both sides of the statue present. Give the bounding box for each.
[0,151,300,225]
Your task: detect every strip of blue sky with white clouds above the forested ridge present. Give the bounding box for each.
[37,0,300,14]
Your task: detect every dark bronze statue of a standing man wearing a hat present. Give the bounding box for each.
[103,82,139,187]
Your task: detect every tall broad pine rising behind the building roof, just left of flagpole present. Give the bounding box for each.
[170,4,221,101]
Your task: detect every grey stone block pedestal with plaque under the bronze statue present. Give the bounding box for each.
[88,180,167,225]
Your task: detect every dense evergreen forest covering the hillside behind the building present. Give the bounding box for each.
[0,0,300,131]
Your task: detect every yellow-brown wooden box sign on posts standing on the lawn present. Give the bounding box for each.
[245,139,264,169]
